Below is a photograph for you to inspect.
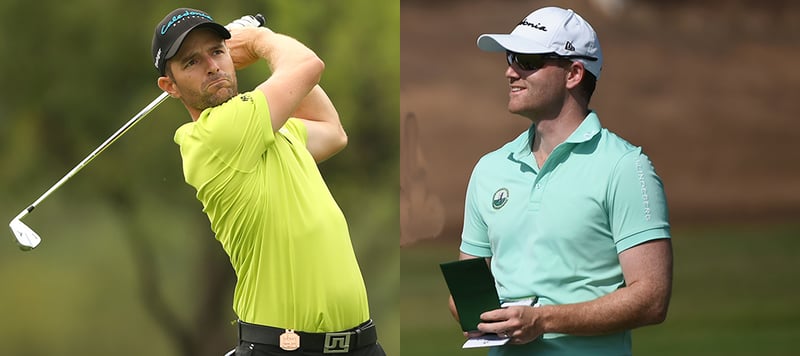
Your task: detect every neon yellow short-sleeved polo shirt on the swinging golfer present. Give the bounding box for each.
[175,90,369,332]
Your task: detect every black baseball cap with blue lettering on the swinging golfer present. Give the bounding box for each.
[153,8,231,76]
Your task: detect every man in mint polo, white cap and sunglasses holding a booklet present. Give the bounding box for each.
[450,7,672,356]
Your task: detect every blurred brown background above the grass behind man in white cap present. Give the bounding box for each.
[400,0,800,245]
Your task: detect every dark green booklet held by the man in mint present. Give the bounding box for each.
[439,258,500,331]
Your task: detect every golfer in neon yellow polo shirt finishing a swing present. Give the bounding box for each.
[153,8,385,356]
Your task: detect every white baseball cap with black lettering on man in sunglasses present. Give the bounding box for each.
[478,7,603,79]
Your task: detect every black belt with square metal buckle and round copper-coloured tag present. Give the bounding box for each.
[239,319,378,354]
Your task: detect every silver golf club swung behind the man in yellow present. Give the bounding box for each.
[8,14,266,251]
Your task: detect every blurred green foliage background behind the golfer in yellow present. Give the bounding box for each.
[0,0,400,356]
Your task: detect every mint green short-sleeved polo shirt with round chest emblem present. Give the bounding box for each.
[460,112,670,356]
